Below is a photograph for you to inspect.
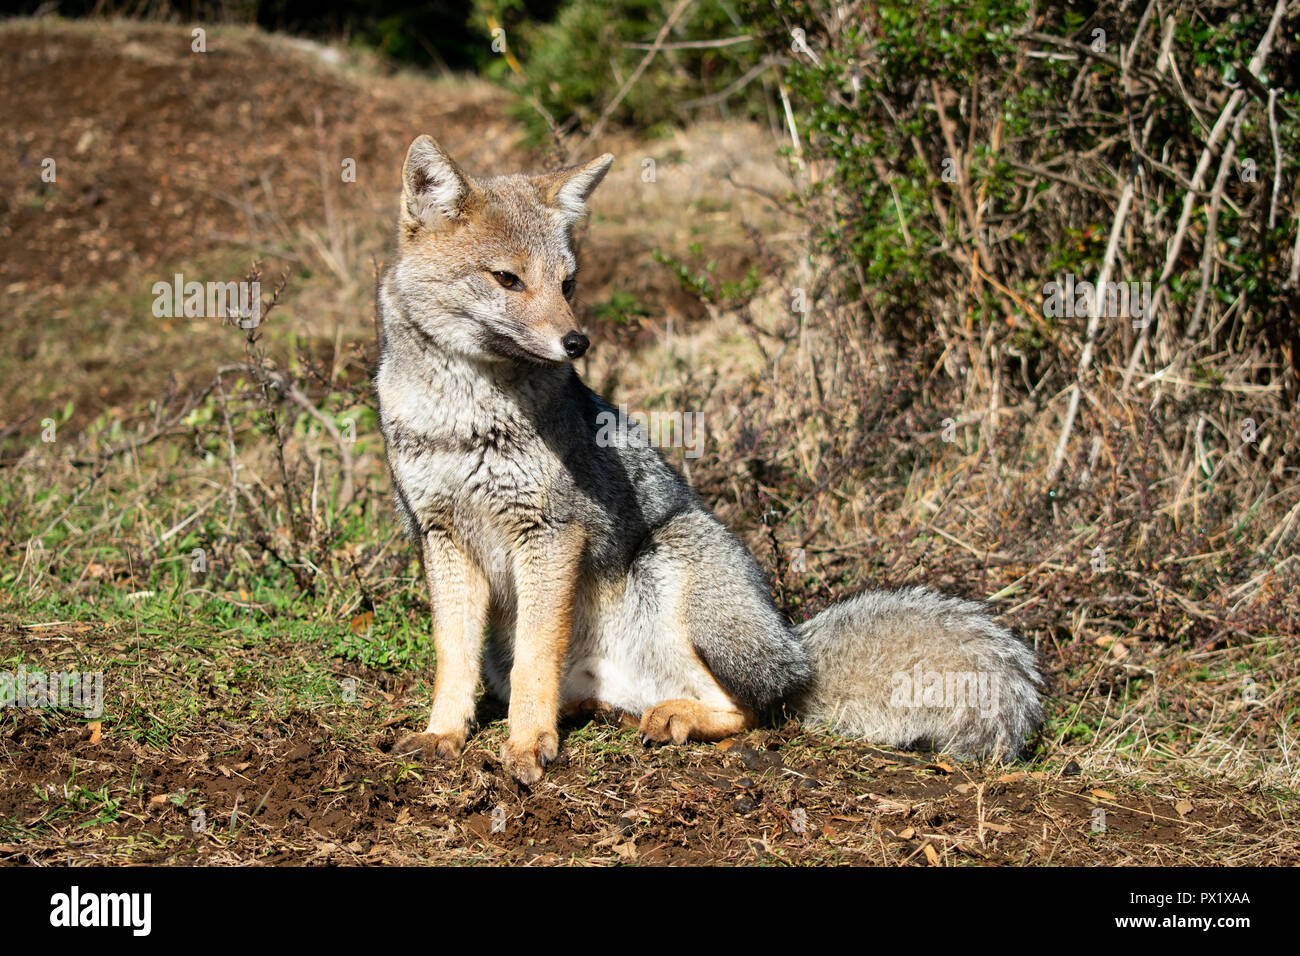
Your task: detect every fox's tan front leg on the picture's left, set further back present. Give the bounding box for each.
[393,531,488,760]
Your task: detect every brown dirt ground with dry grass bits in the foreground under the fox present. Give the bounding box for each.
[0,626,1300,866]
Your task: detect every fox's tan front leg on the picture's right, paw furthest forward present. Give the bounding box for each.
[501,525,585,784]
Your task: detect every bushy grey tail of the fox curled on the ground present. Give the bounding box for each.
[793,588,1043,760]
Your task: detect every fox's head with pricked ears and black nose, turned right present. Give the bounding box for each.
[394,135,614,364]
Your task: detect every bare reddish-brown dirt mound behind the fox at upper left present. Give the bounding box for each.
[0,23,514,293]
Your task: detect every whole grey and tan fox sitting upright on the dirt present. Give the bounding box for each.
[374,135,1041,783]
